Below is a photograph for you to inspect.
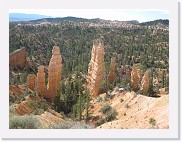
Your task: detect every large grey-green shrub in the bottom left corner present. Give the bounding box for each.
[9,116,40,129]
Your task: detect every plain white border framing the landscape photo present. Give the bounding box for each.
[0,0,180,140]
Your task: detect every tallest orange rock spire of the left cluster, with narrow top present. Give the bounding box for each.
[46,46,62,100]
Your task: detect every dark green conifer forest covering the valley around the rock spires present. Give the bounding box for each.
[9,20,169,129]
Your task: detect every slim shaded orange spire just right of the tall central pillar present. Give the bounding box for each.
[108,57,116,83]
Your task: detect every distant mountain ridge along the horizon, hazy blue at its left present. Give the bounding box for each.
[9,13,169,27]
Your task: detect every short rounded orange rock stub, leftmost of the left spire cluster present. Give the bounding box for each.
[27,74,36,91]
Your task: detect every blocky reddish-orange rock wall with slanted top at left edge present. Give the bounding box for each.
[9,47,26,68]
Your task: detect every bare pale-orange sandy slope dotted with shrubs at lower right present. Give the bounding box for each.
[91,92,169,129]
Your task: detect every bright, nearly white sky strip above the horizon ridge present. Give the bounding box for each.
[9,9,169,22]
